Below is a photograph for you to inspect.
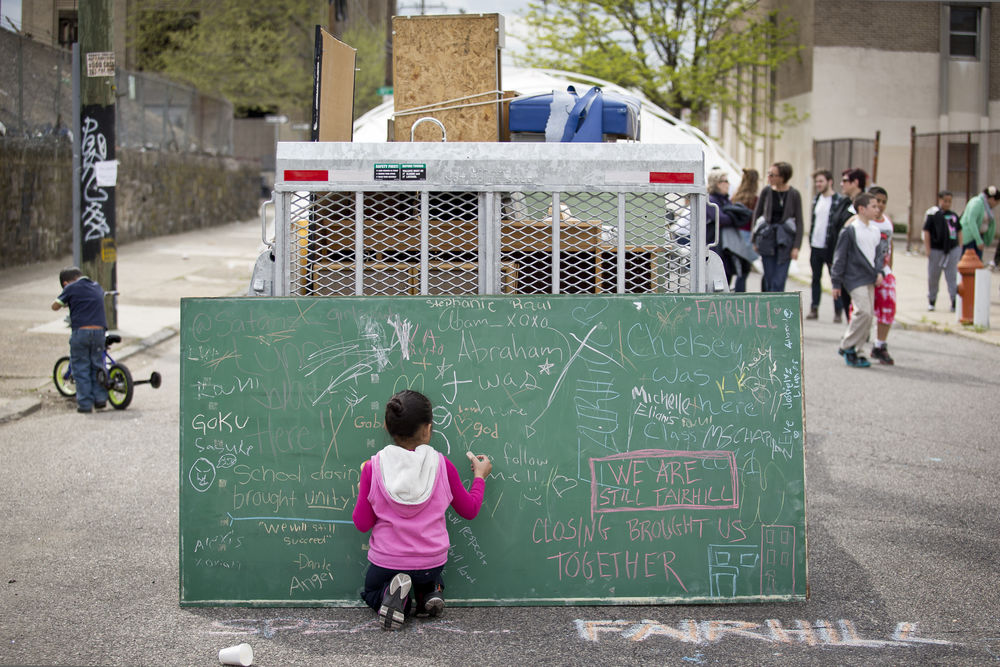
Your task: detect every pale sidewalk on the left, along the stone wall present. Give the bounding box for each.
[0,220,263,423]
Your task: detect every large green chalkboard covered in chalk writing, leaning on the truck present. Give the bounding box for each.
[180,294,806,606]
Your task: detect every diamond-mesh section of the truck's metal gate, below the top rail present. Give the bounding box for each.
[284,191,691,296]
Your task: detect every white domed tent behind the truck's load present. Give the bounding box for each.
[354,66,742,185]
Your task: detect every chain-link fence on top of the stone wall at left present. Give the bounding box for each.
[0,30,233,156]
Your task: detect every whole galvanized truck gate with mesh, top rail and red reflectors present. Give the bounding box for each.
[273,142,707,296]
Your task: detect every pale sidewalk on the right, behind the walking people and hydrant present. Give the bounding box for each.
[789,235,1000,345]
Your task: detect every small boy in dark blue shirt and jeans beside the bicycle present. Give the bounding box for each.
[52,266,108,413]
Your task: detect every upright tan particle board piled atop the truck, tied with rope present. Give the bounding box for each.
[392,14,503,141]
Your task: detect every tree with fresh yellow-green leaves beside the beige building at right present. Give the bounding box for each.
[519,0,799,142]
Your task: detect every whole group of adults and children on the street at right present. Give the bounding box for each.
[708,162,1000,368]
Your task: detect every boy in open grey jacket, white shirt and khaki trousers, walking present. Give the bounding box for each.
[830,192,886,368]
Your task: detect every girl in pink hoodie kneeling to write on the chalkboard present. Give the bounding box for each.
[353,389,493,630]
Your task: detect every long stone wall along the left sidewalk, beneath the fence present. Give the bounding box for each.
[0,136,260,268]
